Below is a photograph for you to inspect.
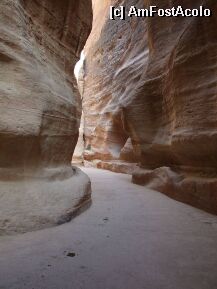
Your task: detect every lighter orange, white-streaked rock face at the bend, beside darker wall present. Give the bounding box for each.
[80,0,147,171]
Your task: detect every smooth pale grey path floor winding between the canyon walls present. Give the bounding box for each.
[0,168,217,289]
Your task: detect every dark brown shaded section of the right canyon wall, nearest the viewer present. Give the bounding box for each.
[130,1,217,213]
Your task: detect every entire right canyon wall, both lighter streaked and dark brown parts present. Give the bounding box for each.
[83,0,217,213]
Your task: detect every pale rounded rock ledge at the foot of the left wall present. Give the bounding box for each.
[0,167,91,236]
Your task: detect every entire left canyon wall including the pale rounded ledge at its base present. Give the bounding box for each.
[0,0,92,233]
